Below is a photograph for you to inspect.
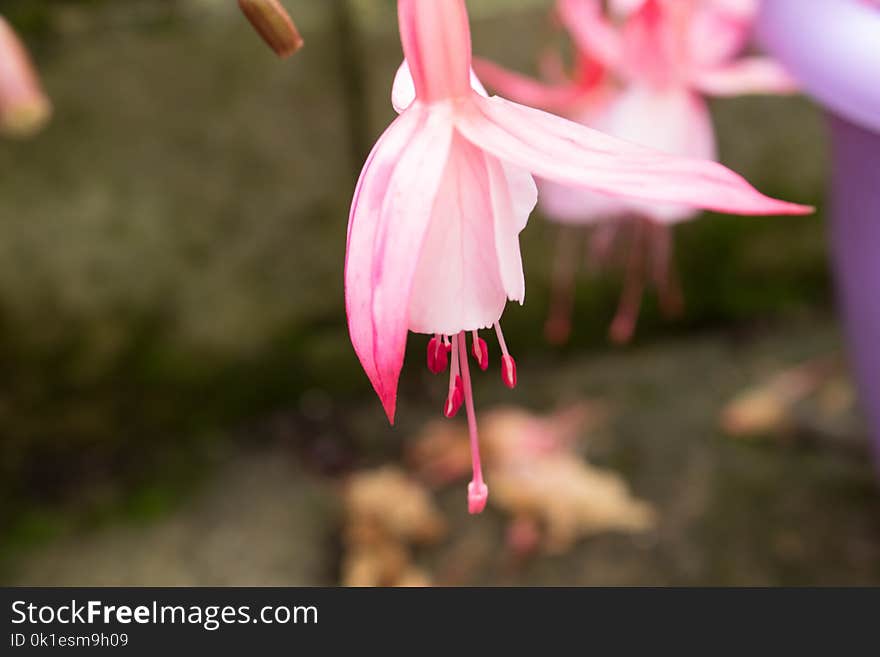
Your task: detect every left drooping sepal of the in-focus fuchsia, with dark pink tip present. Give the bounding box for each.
[345,102,452,422]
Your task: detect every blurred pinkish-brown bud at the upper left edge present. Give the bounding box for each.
[0,17,52,137]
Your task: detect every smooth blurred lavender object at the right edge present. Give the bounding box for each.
[759,0,880,461]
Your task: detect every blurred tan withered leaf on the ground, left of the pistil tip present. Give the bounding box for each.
[342,467,446,586]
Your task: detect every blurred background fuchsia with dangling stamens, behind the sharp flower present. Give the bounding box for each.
[476,0,794,342]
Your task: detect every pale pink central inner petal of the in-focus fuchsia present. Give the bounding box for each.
[409,136,512,335]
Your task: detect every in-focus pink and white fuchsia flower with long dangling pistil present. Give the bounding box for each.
[345,0,809,513]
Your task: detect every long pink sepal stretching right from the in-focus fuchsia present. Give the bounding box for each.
[456,95,811,214]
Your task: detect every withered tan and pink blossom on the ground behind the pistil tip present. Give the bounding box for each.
[410,402,655,554]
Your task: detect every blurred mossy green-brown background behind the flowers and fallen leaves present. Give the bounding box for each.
[0,0,880,584]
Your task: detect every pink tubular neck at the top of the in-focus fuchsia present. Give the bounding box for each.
[397,0,471,103]
